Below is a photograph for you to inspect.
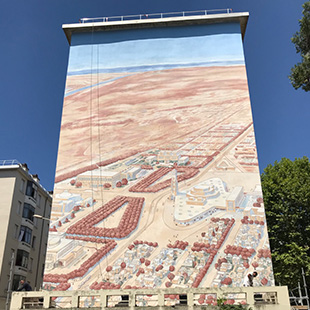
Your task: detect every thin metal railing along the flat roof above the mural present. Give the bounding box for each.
[79,8,232,24]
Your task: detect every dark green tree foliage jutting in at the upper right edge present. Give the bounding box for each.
[289,1,310,91]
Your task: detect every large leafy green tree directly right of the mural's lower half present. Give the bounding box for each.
[261,157,310,289]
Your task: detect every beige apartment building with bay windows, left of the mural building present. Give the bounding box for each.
[0,160,52,309]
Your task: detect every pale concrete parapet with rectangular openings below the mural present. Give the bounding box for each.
[10,286,290,310]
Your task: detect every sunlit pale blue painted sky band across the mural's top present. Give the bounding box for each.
[68,32,244,74]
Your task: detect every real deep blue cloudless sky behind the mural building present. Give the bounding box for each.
[0,0,310,190]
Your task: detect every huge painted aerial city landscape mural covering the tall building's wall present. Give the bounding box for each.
[44,24,274,298]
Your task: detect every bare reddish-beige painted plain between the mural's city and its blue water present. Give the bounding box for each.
[56,66,251,177]
